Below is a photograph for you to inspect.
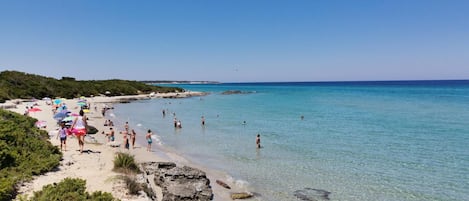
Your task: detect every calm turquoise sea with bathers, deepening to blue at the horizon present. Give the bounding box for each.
[107,80,469,201]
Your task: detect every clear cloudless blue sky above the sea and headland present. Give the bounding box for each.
[0,0,469,82]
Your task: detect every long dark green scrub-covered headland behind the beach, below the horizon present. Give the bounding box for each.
[0,71,184,103]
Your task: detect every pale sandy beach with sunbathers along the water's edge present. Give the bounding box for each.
[3,92,243,201]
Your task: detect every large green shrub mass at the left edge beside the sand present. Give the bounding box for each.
[0,109,62,201]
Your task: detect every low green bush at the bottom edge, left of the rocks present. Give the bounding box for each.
[30,178,118,201]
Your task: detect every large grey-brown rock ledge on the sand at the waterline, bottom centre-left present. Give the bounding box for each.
[142,162,213,201]
